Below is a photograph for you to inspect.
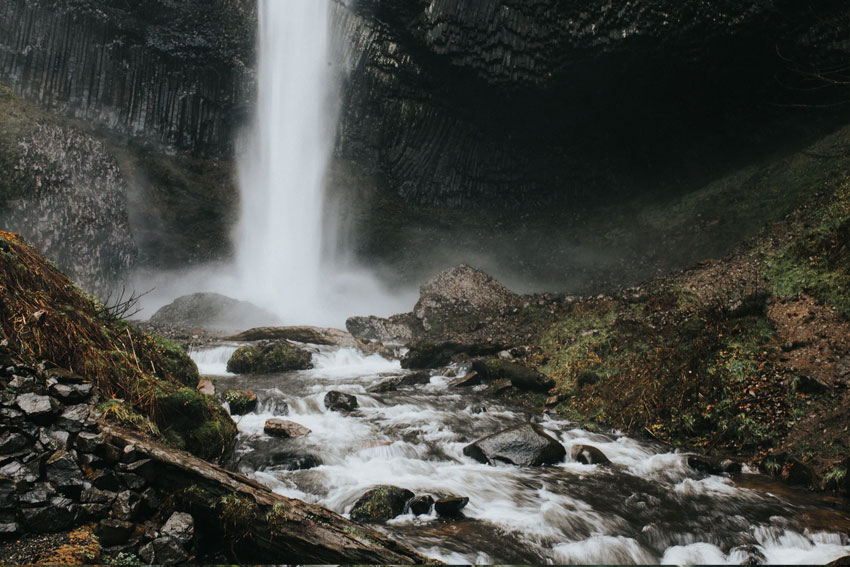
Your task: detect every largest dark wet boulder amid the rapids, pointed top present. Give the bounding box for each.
[463,423,567,466]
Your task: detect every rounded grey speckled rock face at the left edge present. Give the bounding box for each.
[0,125,137,297]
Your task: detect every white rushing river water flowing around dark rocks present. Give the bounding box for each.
[192,345,850,564]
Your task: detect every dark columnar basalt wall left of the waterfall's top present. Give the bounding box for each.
[0,0,254,152]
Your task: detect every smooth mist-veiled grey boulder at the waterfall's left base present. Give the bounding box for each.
[150,293,278,331]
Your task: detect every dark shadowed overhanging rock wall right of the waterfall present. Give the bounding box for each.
[337,0,847,207]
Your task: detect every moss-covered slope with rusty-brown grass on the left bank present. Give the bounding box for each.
[0,232,236,459]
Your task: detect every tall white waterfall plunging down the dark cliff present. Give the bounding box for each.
[236,0,336,321]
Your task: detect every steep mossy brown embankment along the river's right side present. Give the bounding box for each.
[349,123,850,491]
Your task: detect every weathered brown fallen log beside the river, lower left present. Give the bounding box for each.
[102,424,434,564]
